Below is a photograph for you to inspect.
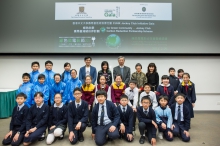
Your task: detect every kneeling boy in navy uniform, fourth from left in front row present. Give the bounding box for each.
[68,87,89,144]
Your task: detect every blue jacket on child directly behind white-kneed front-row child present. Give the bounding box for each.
[50,82,67,105]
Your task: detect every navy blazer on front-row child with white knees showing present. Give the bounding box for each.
[48,105,68,128]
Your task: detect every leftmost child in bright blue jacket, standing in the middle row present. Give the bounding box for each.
[17,73,34,108]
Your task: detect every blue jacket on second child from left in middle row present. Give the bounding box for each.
[32,82,49,104]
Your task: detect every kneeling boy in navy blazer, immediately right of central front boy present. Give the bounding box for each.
[117,95,134,142]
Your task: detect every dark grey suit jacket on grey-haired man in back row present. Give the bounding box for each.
[113,66,131,87]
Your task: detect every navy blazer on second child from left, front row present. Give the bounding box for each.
[26,103,50,131]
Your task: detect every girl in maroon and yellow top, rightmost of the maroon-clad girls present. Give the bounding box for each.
[111,74,126,106]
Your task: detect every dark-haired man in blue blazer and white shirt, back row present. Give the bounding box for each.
[79,56,97,84]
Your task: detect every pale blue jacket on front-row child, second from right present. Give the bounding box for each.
[155,106,173,130]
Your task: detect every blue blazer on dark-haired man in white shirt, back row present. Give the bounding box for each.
[79,66,97,84]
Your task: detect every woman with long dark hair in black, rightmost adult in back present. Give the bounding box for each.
[146,63,159,91]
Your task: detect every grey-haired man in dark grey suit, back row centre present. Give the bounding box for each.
[113,56,131,87]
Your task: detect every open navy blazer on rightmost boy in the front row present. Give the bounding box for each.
[170,103,190,131]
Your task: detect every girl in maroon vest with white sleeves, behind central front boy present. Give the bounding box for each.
[95,75,111,104]
